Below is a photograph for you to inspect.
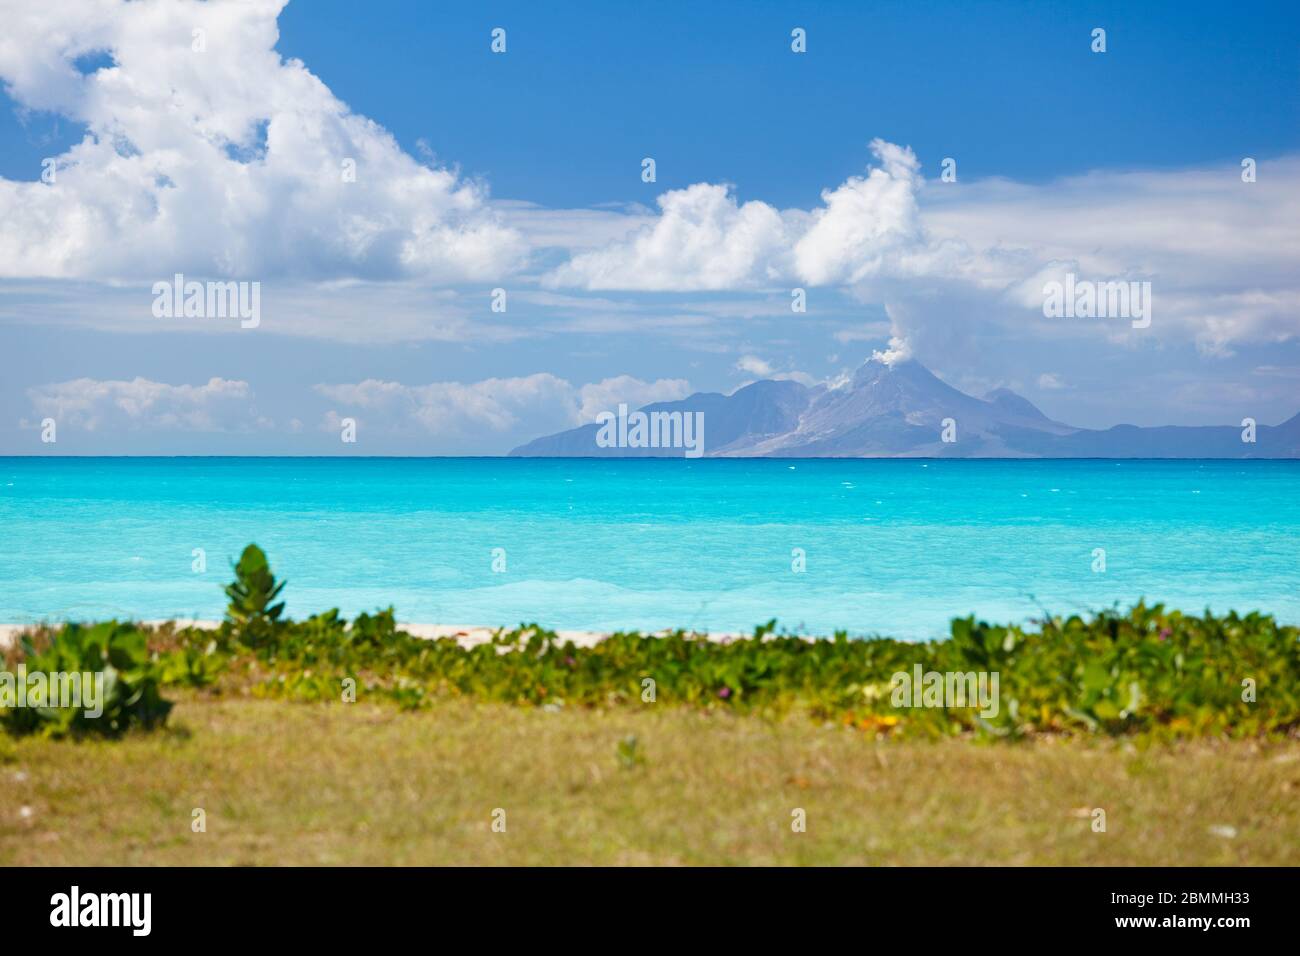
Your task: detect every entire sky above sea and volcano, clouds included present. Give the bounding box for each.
[0,0,1300,454]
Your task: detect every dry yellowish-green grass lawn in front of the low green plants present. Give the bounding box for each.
[0,692,1300,865]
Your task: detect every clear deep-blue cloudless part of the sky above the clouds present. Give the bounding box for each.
[10,0,1300,206]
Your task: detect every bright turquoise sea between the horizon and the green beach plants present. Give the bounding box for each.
[0,458,1300,639]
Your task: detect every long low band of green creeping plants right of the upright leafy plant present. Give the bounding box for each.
[239,605,1300,737]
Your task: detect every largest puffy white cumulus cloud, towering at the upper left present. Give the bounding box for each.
[0,0,525,282]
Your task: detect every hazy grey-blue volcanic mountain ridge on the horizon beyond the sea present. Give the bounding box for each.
[510,359,1300,458]
